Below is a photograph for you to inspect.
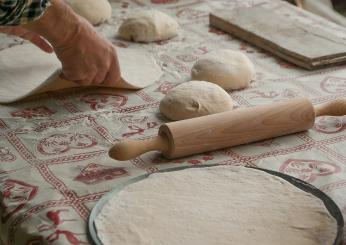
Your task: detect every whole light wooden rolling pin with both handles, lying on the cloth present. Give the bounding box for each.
[109,98,346,161]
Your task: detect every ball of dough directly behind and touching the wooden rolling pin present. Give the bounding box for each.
[160,81,233,120]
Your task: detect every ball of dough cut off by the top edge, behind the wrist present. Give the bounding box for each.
[65,0,112,25]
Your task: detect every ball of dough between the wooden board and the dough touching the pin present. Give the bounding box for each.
[191,49,255,90]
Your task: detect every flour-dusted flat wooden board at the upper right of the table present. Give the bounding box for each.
[209,5,346,69]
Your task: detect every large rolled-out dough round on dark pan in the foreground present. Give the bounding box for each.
[95,166,337,245]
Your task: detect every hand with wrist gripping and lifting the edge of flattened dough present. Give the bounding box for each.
[24,0,120,86]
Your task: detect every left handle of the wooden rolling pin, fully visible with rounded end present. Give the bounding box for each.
[108,135,169,161]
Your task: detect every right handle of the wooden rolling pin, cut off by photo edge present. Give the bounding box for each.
[314,99,346,117]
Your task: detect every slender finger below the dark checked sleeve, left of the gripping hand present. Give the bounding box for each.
[0,26,54,53]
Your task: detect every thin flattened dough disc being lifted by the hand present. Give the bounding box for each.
[0,44,162,103]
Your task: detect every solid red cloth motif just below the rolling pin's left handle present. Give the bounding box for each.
[74,163,128,185]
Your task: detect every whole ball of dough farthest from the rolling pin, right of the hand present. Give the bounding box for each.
[118,10,179,42]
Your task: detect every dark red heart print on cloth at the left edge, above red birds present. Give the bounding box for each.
[1,179,38,222]
